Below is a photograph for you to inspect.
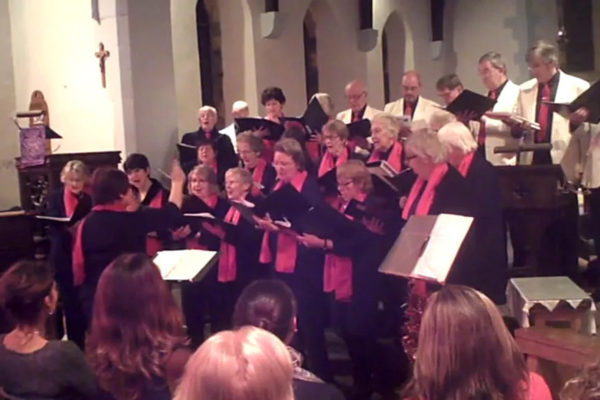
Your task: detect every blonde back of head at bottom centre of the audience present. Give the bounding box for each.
[175,327,294,400]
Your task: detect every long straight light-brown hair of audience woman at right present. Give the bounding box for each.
[409,285,529,400]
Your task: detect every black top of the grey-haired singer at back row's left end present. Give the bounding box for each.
[180,128,237,173]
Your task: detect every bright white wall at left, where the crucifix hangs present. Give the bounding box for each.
[3,0,116,153]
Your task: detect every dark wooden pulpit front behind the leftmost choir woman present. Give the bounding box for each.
[16,151,121,212]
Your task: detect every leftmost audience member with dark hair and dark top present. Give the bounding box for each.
[0,261,96,399]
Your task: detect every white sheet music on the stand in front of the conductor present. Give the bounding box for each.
[153,250,218,282]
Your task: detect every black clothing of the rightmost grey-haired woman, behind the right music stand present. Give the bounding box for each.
[462,152,508,304]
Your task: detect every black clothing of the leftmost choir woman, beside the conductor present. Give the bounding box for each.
[46,187,92,349]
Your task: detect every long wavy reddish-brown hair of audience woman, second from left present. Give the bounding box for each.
[87,253,186,398]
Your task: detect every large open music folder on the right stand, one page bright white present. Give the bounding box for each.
[379,214,473,284]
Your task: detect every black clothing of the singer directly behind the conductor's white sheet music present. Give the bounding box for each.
[181,196,231,348]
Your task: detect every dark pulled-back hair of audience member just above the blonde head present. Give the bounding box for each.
[233,279,297,341]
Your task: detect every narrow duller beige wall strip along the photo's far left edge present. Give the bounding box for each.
[0,1,20,210]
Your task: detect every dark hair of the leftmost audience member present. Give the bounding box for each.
[0,261,54,325]
